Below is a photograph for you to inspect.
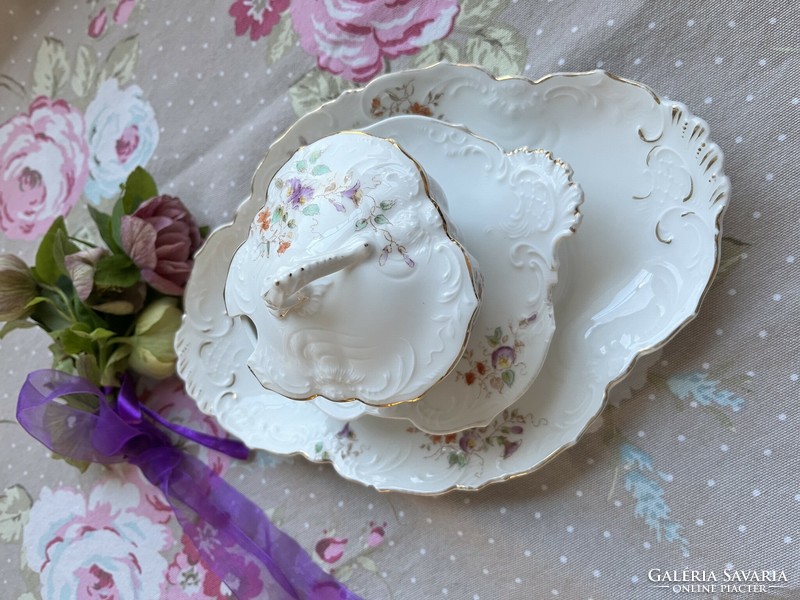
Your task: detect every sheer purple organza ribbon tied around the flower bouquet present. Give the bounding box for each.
[17,369,360,600]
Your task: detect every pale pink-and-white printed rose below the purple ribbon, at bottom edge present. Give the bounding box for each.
[23,474,173,600]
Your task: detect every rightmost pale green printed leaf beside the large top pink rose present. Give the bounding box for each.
[464,25,528,75]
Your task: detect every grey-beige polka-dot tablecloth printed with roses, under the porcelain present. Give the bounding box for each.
[0,0,800,600]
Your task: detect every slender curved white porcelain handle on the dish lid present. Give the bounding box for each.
[264,240,373,318]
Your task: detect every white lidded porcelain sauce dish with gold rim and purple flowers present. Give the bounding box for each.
[225,132,481,407]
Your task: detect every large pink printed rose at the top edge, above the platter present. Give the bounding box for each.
[289,0,459,82]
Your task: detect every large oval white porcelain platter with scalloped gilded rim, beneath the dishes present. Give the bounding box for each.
[176,64,729,494]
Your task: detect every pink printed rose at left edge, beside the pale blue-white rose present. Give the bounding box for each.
[0,96,89,240]
